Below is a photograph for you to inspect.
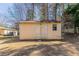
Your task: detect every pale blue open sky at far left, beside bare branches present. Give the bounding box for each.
[0,3,13,25]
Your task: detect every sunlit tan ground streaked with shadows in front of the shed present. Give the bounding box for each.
[0,35,79,56]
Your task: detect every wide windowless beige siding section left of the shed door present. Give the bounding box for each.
[19,23,40,39]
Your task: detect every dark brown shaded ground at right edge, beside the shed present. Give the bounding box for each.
[63,33,79,51]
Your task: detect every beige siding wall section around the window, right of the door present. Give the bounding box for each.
[48,23,61,39]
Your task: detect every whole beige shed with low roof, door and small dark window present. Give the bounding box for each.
[19,20,62,40]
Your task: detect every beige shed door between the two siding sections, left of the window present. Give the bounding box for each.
[40,23,48,39]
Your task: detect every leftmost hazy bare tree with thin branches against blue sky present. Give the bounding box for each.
[8,3,25,21]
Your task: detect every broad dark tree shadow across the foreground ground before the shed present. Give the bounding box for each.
[0,44,78,56]
